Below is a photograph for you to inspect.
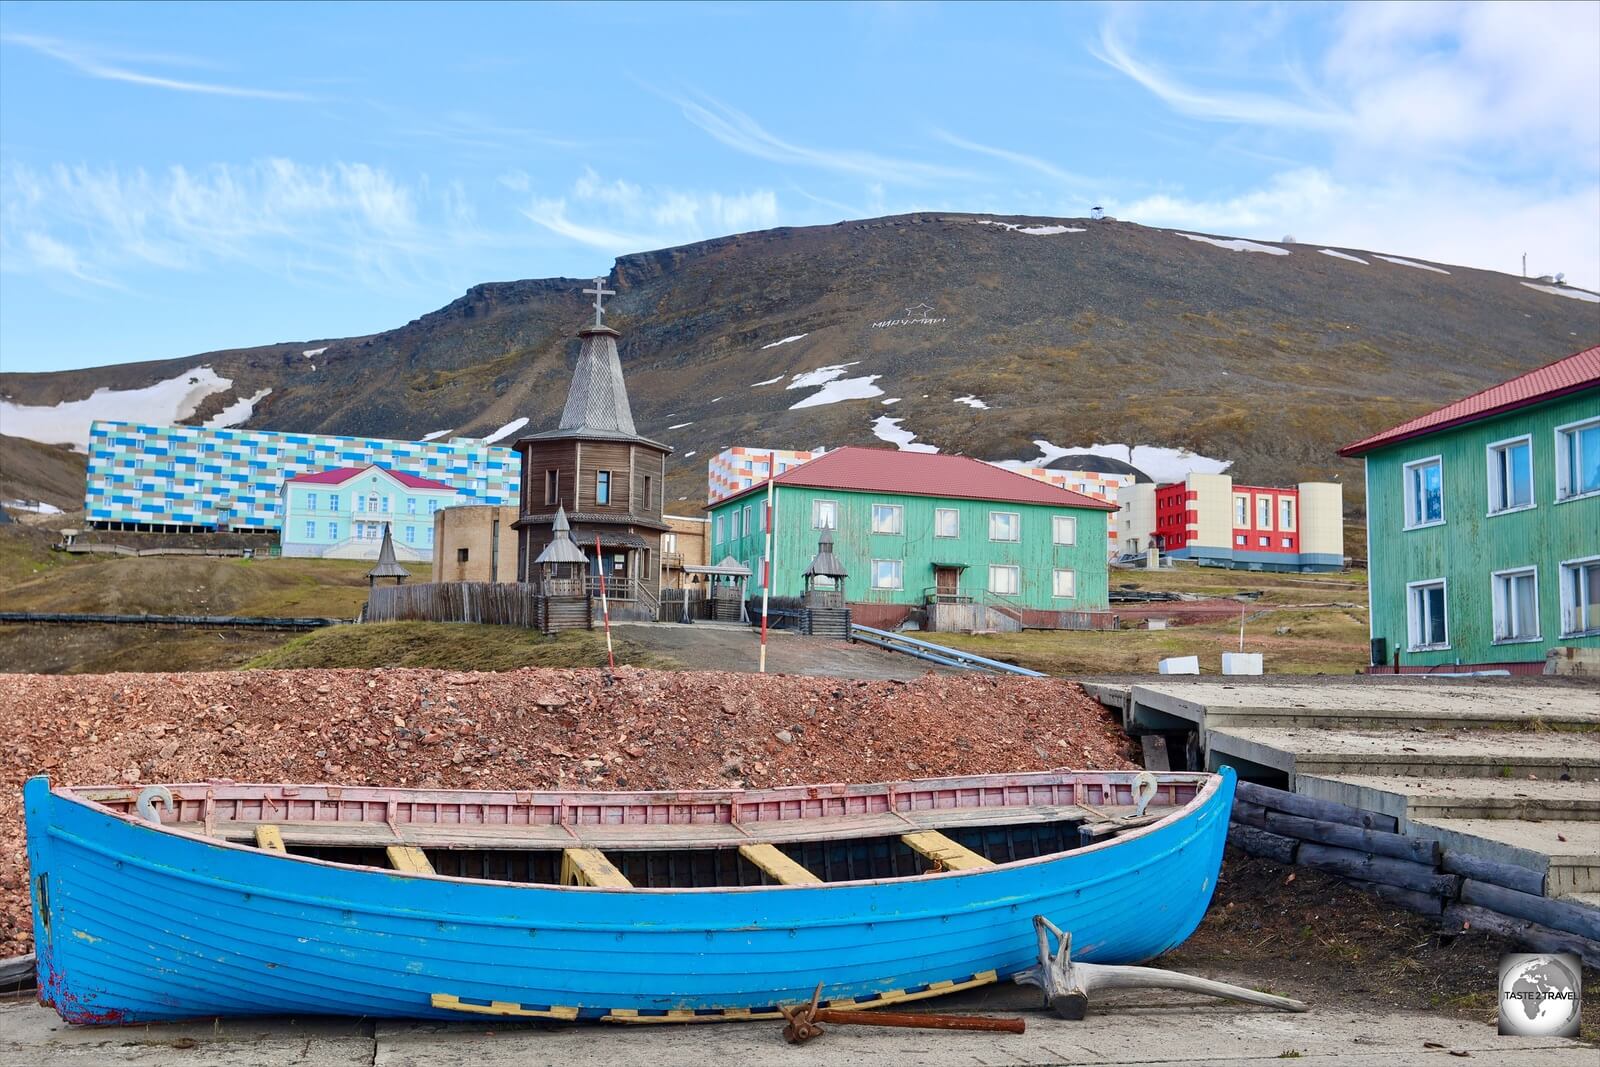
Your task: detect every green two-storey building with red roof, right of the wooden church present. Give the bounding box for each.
[707,448,1114,629]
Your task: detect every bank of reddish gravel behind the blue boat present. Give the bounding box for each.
[0,667,1136,957]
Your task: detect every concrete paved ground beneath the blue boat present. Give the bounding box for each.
[0,987,1589,1067]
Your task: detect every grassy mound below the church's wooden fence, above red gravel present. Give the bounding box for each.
[245,622,677,670]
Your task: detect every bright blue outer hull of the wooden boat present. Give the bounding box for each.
[26,771,1234,1024]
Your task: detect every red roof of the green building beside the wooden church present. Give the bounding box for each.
[717,448,1117,512]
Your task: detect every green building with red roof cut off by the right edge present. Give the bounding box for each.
[1339,347,1600,673]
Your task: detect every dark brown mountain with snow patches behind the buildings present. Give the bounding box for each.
[0,214,1600,507]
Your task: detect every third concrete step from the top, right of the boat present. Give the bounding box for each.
[1294,773,1600,829]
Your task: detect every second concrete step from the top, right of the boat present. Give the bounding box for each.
[1205,726,1600,789]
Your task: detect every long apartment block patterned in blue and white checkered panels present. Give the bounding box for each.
[83,421,522,541]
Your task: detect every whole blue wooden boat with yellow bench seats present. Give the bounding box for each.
[24,771,1234,1024]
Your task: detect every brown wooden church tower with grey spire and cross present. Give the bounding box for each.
[515,278,672,619]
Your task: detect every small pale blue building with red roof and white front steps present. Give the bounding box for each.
[278,464,459,560]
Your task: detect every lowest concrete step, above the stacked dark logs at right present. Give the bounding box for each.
[1410,819,1600,897]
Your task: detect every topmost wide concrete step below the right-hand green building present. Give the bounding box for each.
[1125,680,1600,733]
